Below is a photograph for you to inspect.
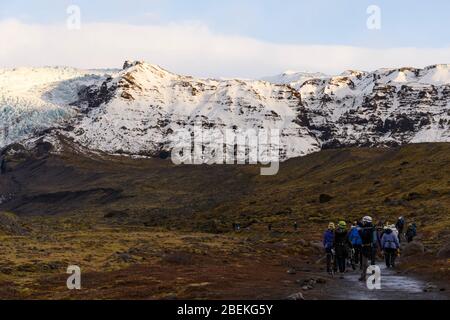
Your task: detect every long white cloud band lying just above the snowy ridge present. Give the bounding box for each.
[0,20,450,77]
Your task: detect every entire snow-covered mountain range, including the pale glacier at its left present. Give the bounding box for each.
[0,62,450,158]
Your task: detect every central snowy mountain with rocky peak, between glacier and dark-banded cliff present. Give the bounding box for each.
[67,63,320,158]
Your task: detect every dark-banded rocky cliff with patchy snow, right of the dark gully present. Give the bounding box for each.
[299,65,450,147]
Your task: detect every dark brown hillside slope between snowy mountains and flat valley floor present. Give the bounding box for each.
[0,140,450,238]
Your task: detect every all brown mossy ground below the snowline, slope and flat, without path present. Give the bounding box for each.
[0,144,450,299]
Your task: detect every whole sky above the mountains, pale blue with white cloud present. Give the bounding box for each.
[0,0,450,78]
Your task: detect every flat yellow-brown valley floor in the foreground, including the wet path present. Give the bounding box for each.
[0,217,450,300]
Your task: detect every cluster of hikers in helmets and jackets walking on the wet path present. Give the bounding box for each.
[323,216,417,281]
